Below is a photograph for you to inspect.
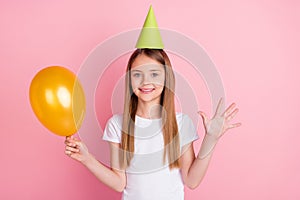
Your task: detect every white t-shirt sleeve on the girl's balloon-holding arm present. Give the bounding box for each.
[102,115,122,143]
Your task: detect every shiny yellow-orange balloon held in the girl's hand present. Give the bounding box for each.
[29,66,85,136]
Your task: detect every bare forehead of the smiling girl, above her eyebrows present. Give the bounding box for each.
[131,54,164,70]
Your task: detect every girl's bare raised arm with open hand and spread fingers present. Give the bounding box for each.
[180,98,241,189]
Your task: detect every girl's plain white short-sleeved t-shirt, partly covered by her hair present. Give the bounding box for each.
[103,113,198,200]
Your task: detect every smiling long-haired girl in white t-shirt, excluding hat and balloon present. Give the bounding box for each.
[65,49,241,200]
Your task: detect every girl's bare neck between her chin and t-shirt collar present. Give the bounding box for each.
[136,101,162,119]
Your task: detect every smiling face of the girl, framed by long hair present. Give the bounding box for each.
[130,54,165,104]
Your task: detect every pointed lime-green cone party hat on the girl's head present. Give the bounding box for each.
[135,6,164,49]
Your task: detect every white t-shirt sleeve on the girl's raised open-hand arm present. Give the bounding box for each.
[178,114,199,147]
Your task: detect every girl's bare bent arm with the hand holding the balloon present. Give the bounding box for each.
[65,137,126,192]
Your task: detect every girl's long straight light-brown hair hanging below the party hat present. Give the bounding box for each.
[120,49,180,169]
